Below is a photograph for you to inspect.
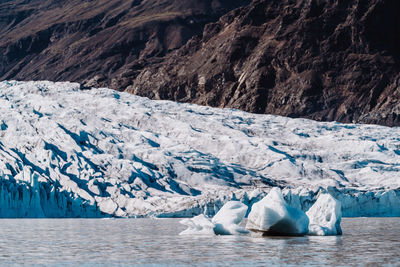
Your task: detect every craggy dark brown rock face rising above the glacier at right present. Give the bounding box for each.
[127,0,400,126]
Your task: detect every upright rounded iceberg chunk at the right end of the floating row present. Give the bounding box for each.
[307,194,342,235]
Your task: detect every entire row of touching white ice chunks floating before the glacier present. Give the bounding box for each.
[180,191,342,236]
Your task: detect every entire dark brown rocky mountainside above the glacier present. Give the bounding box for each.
[0,0,400,126]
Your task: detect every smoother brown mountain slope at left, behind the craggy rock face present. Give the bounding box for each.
[0,0,250,89]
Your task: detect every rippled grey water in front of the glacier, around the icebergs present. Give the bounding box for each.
[0,218,400,266]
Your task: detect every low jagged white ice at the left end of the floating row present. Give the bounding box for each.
[180,201,248,235]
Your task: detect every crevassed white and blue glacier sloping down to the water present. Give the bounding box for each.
[0,81,400,218]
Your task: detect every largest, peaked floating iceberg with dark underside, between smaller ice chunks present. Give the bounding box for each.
[246,188,309,235]
